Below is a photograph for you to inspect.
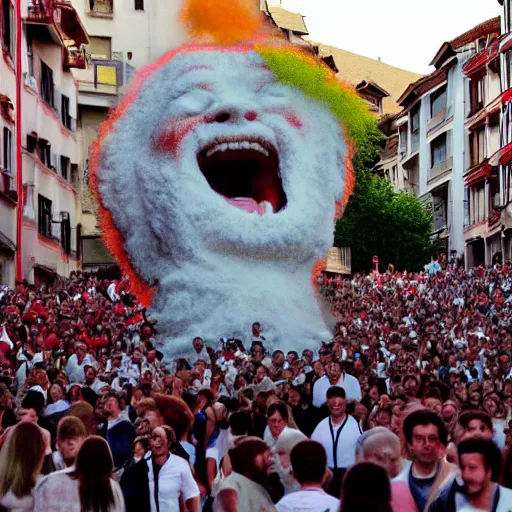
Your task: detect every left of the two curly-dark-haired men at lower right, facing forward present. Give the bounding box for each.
[393,409,457,512]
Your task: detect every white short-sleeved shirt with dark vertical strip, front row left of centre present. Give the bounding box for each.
[147,455,199,512]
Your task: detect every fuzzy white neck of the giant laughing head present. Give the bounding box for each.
[150,255,333,355]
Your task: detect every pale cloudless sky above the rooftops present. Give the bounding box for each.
[280,0,501,73]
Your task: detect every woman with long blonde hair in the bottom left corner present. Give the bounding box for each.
[0,423,46,512]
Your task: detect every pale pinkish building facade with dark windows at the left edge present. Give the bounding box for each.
[0,0,88,286]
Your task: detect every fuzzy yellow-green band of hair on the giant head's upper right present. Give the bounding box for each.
[256,46,377,149]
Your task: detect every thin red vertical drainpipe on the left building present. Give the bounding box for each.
[14,0,23,281]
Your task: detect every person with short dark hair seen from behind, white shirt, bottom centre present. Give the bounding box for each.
[276,440,340,512]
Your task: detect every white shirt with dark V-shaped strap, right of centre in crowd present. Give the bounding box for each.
[311,416,361,469]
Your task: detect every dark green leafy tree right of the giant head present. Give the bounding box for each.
[334,127,435,272]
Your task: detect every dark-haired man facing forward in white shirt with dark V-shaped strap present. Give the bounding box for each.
[311,386,361,496]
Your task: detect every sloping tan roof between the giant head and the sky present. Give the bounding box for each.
[313,43,422,114]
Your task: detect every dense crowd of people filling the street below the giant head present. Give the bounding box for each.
[0,265,512,512]
